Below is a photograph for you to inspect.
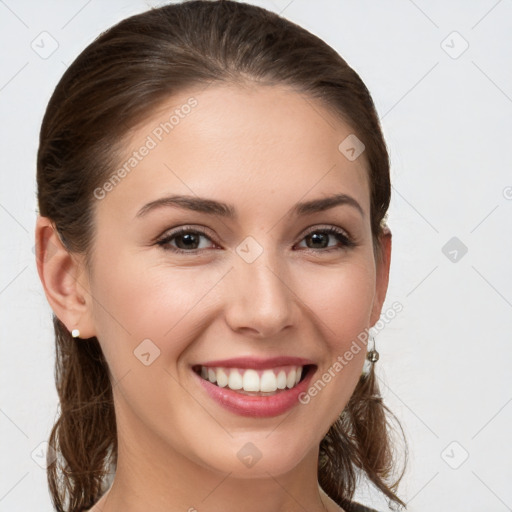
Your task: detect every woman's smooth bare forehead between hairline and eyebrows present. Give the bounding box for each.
[94,84,369,220]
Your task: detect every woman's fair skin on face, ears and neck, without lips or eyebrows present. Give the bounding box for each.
[36,84,391,512]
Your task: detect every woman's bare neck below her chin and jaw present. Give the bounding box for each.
[95,402,341,512]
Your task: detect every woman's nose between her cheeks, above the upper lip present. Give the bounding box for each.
[225,252,299,339]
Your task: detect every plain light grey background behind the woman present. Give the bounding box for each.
[0,0,512,512]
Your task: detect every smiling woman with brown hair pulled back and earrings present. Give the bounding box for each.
[36,1,404,512]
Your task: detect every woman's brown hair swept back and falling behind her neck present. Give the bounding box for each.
[37,0,406,512]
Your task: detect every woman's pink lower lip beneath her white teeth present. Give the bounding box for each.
[192,367,315,418]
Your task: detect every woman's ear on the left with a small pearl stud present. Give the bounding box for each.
[35,216,96,338]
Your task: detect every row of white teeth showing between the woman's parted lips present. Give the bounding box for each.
[192,364,315,396]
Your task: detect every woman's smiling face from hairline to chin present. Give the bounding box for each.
[76,85,388,477]
